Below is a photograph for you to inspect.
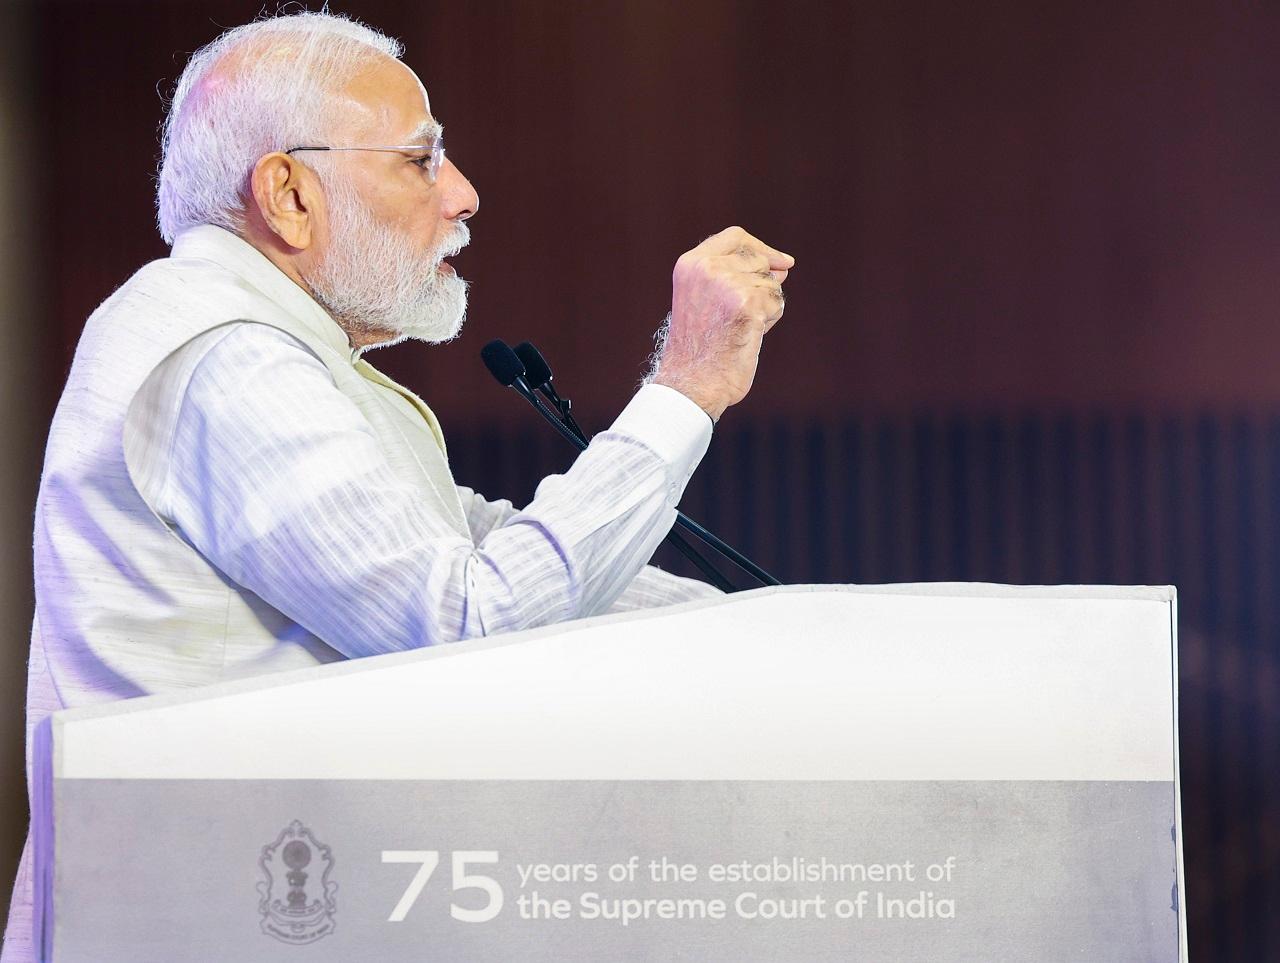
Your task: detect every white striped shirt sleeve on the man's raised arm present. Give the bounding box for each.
[156,324,712,656]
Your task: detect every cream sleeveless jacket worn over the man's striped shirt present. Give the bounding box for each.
[28,225,470,722]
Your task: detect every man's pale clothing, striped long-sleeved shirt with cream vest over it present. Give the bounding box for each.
[3,227,714,963]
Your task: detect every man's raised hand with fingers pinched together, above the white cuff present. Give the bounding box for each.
[650,228,795,421]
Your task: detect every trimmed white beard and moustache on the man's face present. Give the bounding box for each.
[302,177,471,344]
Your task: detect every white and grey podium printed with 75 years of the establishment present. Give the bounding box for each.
[33,584,1187,963]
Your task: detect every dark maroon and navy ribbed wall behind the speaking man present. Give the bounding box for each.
[0,0,1280,960]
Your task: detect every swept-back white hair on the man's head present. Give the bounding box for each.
[156,12,404,243]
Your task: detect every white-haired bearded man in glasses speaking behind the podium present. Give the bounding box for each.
[4,14,792,962]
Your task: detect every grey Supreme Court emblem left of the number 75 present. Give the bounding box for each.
[257,820,338,944]
